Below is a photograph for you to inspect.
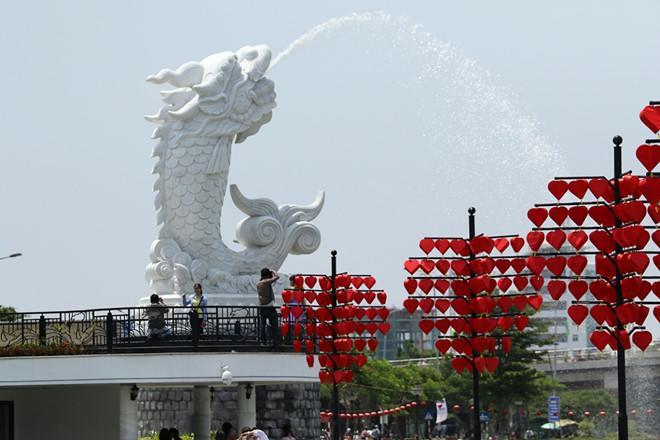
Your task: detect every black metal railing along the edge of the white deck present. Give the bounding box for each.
[0,306,292,356]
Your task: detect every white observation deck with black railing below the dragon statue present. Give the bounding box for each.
[0,306,318,387]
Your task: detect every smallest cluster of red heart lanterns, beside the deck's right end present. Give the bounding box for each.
[280,274,390,384]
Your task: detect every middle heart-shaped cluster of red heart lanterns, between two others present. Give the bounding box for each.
[403,235,544,373]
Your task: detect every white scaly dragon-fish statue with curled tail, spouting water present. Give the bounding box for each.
[145,45,324,305]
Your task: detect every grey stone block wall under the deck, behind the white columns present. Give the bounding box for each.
[137,384,321,440]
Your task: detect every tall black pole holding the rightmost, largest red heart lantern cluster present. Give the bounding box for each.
[612,136,628,440]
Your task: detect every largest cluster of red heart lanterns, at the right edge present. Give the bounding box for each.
[527,133,660,350]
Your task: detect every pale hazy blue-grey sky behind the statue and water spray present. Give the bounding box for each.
[0,1,660,338]
